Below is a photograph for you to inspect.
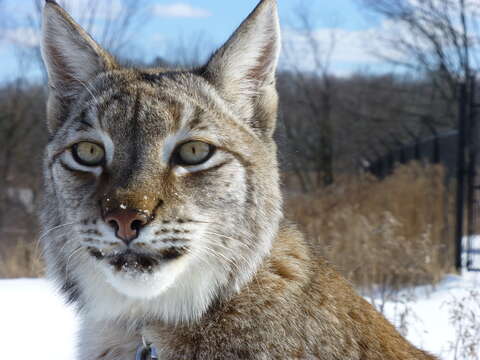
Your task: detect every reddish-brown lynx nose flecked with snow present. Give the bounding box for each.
[105,209,148,245]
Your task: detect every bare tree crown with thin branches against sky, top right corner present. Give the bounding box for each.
[358,0,480,101]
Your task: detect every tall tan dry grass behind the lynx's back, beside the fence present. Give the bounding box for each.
[285,163,453,296]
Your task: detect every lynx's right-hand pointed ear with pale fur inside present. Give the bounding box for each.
[205,0,281,135]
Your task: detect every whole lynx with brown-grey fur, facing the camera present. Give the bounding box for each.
[41,0,433,360]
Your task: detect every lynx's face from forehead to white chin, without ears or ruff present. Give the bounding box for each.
[49,73,251,297]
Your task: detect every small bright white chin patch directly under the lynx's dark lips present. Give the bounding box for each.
[102,258,188,299]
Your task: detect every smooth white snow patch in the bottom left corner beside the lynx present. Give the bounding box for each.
[0,279,78,360]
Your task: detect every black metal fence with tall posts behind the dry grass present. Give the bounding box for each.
[363,77,480,271]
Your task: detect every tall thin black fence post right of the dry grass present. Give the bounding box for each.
[455,82,467,271]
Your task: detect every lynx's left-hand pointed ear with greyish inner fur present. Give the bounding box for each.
[42,0,116,130]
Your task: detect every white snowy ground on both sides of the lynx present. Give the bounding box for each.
[0,273,480,360]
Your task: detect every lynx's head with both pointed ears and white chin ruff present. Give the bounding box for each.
[42,0,281,322]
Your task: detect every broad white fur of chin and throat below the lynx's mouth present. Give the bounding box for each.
[75,250,229,324]
